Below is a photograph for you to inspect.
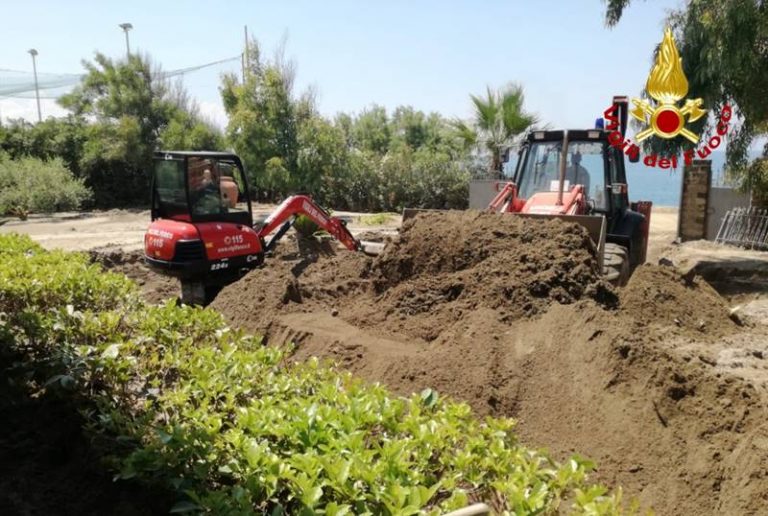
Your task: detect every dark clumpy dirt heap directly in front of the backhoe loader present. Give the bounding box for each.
[374,211,615,320]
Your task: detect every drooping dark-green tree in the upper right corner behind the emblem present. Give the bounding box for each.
[606,0,768,197]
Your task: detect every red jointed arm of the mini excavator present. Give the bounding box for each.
[257,195,361,251]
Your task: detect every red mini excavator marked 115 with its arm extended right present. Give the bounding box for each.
[144,151,375,305]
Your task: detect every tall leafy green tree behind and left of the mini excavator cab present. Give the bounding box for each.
[59,53,223,207]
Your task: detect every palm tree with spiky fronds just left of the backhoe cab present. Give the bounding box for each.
[453,84,537,176]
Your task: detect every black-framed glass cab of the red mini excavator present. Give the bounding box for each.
[152,152,253,226]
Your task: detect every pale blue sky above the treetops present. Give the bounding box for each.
[0,0,680,127]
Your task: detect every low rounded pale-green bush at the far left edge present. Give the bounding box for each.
[0,154,91,219]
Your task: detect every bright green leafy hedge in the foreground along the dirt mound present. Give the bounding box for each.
[0,236,620,515]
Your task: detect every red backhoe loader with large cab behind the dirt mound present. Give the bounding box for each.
[403,97,652,286]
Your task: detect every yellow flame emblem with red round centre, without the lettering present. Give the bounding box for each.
[631,28,707,143]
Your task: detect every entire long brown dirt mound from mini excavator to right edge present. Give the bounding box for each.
[204,212,768,514]
